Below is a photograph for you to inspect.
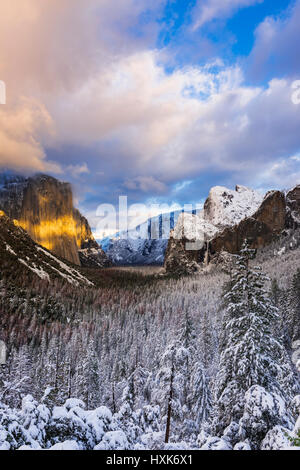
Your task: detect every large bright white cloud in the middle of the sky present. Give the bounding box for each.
[53,51,300,187]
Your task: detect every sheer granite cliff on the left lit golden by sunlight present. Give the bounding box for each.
[0,175,105,265]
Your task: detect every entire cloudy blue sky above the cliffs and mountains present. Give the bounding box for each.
[0,0,300,235]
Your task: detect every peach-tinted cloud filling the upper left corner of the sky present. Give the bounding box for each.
[0,0,165,171]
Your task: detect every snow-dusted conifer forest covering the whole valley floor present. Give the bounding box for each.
[0,237,300,450]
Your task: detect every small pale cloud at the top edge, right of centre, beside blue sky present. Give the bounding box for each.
[193,0,263,31]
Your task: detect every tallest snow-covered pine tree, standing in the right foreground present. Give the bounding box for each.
[214,242,296,448]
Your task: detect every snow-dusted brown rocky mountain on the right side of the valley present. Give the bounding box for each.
[165,186,300,273]
